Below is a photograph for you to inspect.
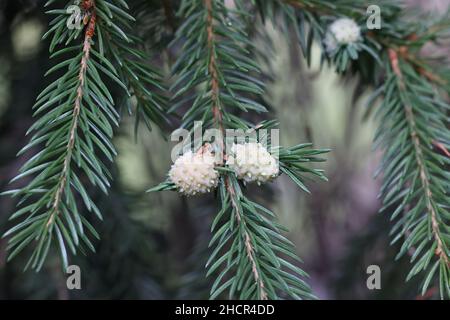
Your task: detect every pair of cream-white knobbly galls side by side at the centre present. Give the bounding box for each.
[169,142,279,195]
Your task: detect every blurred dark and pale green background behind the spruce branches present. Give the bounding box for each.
[0,0,449,299]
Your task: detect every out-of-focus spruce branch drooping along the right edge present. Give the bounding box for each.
[270,0,450,298]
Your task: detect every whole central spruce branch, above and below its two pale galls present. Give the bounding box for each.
[149,0,328,300]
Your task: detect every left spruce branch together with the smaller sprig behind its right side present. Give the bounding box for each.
[4,0,167,270]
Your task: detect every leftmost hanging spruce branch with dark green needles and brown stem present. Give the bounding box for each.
[4,1,110,270]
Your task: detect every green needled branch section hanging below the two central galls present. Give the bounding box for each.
[206,174,314,299]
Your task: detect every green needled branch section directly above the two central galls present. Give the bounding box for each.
[170,1,267,129]
